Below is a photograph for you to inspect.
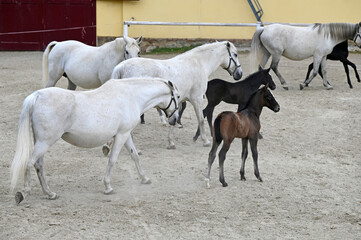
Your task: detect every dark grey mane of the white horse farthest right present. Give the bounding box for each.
[313,23,358,40]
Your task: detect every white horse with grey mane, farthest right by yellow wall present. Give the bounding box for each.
[251,22,361,90]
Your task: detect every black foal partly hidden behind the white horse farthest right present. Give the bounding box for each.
[306,41,360,88]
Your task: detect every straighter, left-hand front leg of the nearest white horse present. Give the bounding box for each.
[104,132,130,194]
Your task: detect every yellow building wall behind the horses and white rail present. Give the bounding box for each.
[97,0,361,39]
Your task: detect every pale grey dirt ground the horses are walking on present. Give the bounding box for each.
[0,49,361,239]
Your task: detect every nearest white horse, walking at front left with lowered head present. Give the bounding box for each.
[11,78,179,199]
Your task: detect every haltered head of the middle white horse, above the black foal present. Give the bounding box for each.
[223,42,242,80]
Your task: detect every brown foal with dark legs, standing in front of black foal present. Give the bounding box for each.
[205,84,280,188]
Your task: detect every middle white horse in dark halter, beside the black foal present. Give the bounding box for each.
[108,41,242,151]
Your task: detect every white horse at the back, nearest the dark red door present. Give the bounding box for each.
[43,37,142,90]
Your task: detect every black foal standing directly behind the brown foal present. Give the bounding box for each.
[193,69,276,141]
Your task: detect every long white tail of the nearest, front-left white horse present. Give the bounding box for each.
[10,93,38,192]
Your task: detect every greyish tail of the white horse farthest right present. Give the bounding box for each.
[250,28,268,72]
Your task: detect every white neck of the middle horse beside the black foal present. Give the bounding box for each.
[186,42,225,77]
